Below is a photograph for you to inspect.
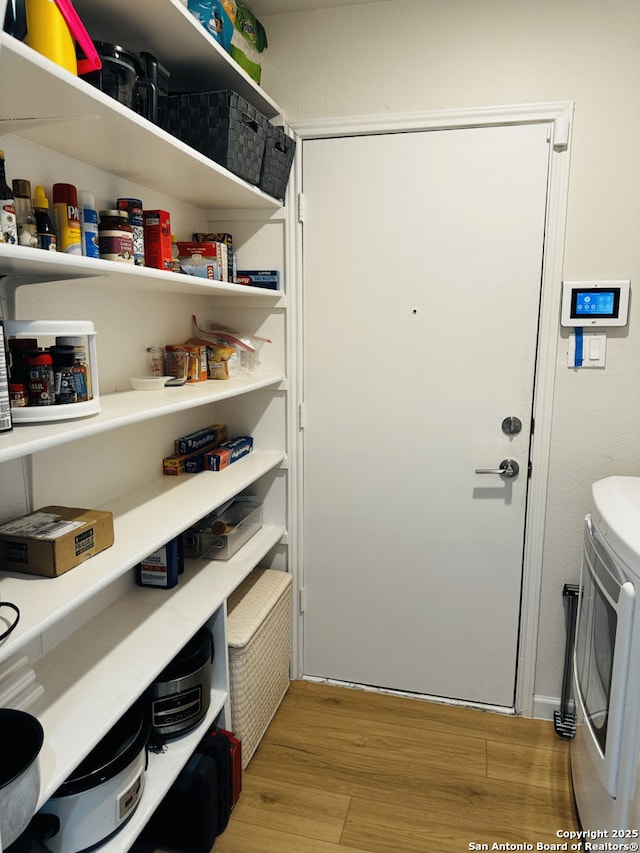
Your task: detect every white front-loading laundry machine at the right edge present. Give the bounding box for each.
[571,477,640,836]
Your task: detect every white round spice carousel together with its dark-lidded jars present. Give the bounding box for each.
[5,320,100,426]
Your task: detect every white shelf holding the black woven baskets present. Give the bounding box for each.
[0,35,282,210]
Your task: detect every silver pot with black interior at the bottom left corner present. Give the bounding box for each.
[0,708,44,848]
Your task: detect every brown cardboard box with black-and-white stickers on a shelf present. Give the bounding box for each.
[0,506,113,578]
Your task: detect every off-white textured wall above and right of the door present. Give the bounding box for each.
[262,0,640,710]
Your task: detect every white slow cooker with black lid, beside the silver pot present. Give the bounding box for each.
[39,701,150,853]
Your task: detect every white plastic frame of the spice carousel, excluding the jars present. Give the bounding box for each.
[4,320,101,425]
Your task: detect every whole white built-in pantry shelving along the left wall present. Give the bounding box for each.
[0,0,287,853]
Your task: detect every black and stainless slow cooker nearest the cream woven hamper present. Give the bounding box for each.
[151,627,214,739]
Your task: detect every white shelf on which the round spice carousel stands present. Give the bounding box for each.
[0,373,284,463]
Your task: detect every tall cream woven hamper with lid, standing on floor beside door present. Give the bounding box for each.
[227,569,291,770]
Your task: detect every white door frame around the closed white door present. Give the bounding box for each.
[286,101,574,716]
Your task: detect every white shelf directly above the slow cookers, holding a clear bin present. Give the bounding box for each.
[31,526,283,808]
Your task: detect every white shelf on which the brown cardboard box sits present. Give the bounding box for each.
[0,451,285,664]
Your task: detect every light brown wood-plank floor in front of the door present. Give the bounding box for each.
[213,682,577,853]
